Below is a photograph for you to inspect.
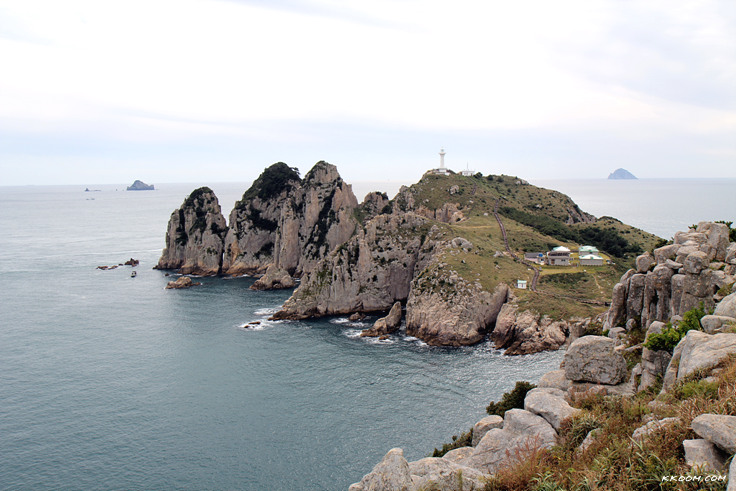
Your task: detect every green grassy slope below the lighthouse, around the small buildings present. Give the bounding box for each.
[392,174,659,319]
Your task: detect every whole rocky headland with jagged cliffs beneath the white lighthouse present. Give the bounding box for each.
[159,162,650,354]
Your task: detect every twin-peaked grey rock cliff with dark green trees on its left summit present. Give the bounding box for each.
[223,162,358,276]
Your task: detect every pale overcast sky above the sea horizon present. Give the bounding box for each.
[0,0,736,185]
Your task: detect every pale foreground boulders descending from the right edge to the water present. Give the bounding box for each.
[350,222,736,491]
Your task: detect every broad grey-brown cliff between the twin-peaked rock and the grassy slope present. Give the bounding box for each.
[274,217,508,346]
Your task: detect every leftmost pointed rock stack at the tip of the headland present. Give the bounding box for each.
[155,187,227,276]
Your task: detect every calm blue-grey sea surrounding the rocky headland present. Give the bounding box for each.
[0,180,736,490]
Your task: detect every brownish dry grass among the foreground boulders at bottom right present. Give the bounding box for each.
[486,357,736,491]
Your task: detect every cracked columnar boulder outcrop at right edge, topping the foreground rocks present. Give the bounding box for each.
[605,222,736,329]
